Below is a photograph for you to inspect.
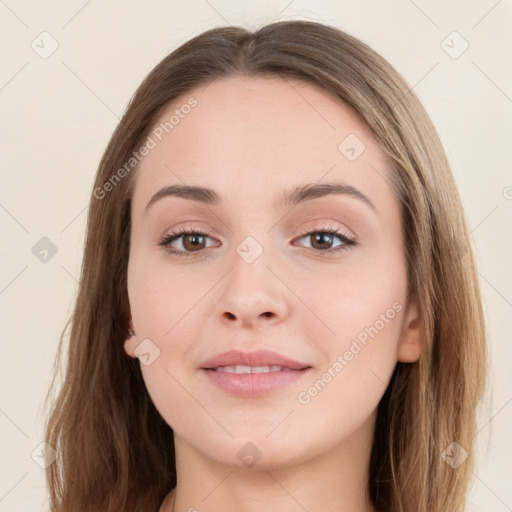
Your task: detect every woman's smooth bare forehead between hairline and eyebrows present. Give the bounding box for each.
[133,76,391,209]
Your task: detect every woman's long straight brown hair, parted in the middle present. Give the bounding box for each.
[46,20,487,512]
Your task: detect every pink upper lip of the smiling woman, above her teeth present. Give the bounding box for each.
[201,350,310,370]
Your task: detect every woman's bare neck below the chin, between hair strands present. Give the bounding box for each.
[159,416,374,512]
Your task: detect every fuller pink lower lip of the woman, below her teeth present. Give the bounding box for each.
[202,368,312,397]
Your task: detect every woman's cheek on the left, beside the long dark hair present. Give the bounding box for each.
[128,255,218,420]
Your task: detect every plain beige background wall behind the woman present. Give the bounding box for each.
[0,0,512,512]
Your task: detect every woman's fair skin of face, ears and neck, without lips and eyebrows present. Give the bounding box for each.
[125,73,421,512]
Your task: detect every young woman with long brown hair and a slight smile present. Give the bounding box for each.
[47,21,486,512]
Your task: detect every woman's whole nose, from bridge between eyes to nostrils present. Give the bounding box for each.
[216,235,287,324]
